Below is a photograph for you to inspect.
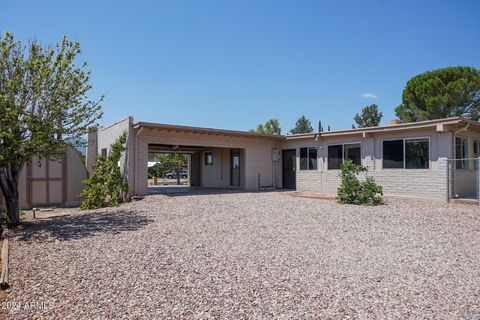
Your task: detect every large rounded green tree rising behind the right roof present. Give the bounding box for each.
[395,67,480,123]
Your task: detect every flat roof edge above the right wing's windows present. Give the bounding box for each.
[286,117,480,139]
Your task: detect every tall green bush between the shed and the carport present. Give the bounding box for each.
[80,132,128,210]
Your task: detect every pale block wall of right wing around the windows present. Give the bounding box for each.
[282,129,458,199]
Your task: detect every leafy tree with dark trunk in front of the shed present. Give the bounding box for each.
[0,32,103,225]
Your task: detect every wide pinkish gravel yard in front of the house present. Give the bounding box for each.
[6,192,480,319]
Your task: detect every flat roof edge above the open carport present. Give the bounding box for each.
[133,122,285,139]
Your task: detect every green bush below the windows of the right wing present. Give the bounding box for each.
[337,160,383,204]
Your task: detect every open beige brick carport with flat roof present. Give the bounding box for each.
[129,122,283,195]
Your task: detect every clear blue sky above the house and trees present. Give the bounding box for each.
[0,0,480,133]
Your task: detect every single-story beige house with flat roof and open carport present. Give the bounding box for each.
[87,117,480,200]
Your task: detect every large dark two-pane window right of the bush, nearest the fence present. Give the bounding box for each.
[383,138,430,169]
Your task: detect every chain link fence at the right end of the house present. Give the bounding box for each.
[446,158,480,205]
